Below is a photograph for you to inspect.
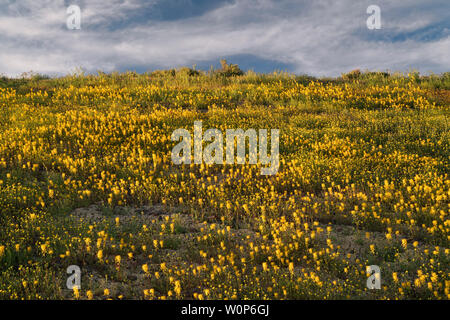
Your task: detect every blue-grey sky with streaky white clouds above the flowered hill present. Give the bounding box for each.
[0,0,450,77]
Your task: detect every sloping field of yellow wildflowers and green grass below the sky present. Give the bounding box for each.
[0,69,450,300]
